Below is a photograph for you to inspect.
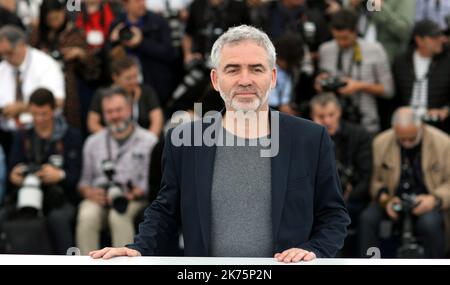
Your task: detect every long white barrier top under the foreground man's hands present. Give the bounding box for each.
[0,254,450,266]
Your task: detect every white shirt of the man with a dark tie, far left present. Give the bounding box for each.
[0,47,66,129]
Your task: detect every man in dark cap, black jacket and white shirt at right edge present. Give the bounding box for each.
[393,20,450,132]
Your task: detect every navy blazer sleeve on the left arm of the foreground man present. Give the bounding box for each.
[127,131,180,256]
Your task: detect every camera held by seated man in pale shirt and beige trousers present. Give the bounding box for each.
[102,160,128,214]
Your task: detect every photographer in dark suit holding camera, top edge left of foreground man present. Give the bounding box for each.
[109,0,174,105]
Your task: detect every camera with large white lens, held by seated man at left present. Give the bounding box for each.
[17,164,44,215]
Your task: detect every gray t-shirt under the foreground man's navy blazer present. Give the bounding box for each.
[210,127,273,257]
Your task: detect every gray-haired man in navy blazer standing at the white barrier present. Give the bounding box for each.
[90,25,349,263]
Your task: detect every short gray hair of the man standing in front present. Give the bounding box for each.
[211,25,277,69]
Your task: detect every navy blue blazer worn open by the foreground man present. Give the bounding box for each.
[127,111,350,257]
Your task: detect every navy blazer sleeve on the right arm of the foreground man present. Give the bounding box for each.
[298,128,350,255]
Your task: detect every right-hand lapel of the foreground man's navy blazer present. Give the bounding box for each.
[271,111,291,241]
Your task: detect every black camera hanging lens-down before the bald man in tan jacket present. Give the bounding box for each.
[392,192,425,258]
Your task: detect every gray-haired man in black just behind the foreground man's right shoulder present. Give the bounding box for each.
[310,93,372,225]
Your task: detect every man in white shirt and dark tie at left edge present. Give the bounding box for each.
[0,25,65,155]
